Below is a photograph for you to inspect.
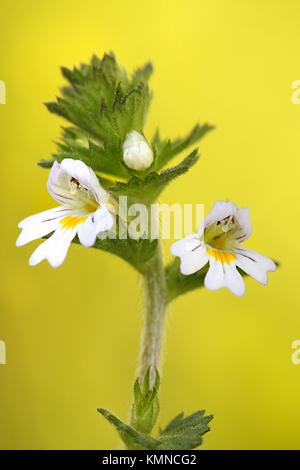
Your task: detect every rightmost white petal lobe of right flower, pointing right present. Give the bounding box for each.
[234,248,276,285]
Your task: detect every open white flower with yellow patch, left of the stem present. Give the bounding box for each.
[16,158,114,267]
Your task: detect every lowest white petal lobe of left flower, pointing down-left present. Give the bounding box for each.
[29,228,76,268]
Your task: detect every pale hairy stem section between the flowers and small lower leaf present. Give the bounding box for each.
[139,242,166,383]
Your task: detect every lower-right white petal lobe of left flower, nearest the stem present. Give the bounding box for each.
[78,204,114,250]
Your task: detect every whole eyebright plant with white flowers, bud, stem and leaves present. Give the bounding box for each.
[17,54,276,450]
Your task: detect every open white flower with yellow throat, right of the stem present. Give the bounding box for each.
[171,201,276,296]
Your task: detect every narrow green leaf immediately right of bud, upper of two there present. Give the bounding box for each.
[152,123,214,170]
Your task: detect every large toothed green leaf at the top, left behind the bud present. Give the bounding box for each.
[41,54,152,177]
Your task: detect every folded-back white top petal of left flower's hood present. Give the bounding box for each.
[61,158,108,203]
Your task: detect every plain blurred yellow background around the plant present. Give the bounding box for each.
[0,0,300,449]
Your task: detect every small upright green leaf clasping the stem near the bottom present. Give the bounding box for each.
[131,367,159,434]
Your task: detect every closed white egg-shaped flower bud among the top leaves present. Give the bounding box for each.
[123,131,153,171]
